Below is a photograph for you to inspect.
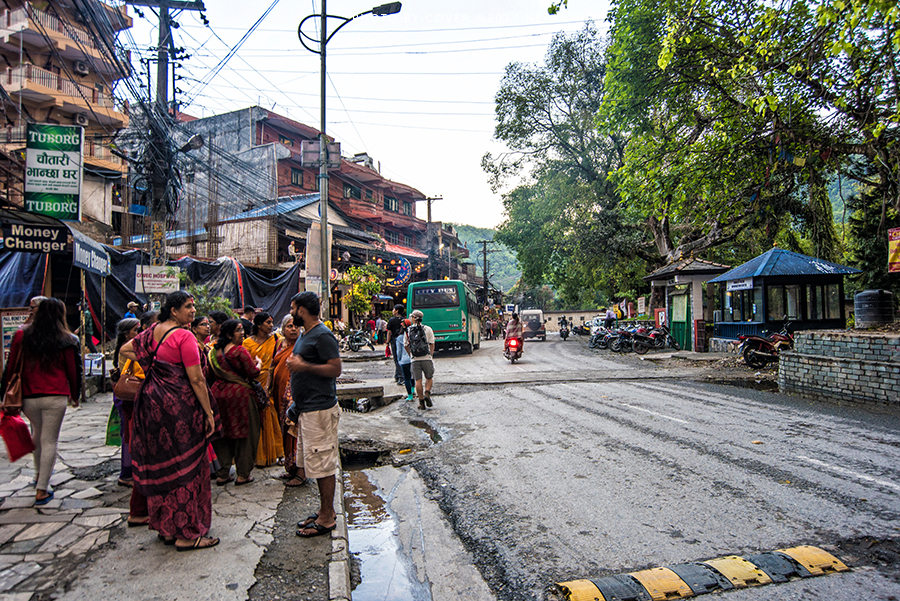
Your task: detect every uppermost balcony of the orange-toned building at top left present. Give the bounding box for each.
[0,4,131,79]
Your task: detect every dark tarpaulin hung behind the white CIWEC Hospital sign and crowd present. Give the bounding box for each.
[81,247,300,336]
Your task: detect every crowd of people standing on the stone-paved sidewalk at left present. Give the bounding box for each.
[0,291,342,551]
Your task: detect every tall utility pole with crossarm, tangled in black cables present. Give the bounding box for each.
[125,0,206,266]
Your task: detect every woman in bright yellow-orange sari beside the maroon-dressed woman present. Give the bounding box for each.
[244,312,284,467]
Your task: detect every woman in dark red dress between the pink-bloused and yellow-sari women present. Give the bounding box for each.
[209,319,261,486]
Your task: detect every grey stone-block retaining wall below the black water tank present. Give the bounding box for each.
[778,330,900,408]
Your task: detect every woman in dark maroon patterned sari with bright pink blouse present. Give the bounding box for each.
[120,291,220,551]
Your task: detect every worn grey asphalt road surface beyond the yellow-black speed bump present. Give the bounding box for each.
[342,336,900,600]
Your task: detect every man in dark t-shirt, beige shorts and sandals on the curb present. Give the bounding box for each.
[287,292,341,538]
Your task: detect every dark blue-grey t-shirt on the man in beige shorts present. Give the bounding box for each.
[291,322,341,413]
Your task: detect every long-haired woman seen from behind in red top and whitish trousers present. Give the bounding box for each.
[0,298,82,506]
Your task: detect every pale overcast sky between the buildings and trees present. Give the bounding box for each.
[123,0,608,227]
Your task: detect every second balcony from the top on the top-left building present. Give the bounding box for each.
[4,64,128,128]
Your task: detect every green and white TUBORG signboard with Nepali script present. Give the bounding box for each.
[25,123,84,221]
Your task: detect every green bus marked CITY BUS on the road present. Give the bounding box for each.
[406,280,481,354]
